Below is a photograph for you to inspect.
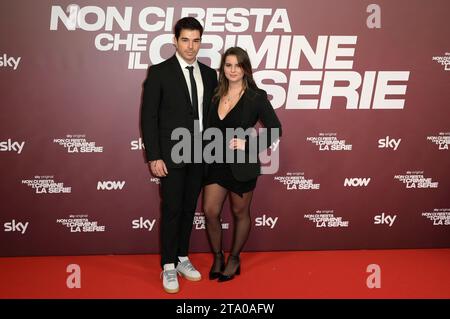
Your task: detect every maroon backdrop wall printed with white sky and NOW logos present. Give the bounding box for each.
[0,0,450,256]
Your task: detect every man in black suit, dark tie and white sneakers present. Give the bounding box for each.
[141,17,217,293]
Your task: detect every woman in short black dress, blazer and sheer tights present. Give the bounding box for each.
[203,47,281,281]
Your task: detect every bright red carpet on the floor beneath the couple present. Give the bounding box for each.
[0,249,450,299]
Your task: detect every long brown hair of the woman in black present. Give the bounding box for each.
[213,47,258,101]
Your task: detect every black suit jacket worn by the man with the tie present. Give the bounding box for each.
[141,55,217,167]
